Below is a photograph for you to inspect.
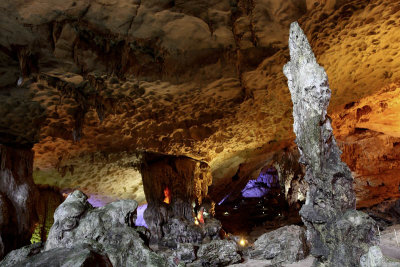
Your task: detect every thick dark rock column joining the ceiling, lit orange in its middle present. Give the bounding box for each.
[140,153,212,242]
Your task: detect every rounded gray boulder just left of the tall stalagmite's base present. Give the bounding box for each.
[250,225,308,263]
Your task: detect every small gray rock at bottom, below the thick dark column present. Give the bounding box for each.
[196,240,241,266]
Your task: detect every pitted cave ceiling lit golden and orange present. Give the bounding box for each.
[0,0,400,205]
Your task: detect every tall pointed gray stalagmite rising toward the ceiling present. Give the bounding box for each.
[284,22,376,266]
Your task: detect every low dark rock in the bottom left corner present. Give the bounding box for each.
[0,244,113,267]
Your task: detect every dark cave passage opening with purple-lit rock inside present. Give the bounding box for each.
[215,168,302,239]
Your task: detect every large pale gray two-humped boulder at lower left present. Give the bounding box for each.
[45,191,165,266]
